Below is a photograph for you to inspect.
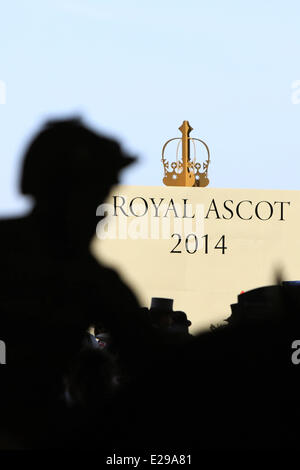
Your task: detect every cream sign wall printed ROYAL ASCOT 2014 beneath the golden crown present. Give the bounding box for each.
[92,186,300,332]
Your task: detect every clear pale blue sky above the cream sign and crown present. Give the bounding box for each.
[0,0,300,214]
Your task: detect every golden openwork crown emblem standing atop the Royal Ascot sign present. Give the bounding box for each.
[161,121,210,187]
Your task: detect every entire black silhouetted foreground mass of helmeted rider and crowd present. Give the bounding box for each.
[0,120,300,452]
